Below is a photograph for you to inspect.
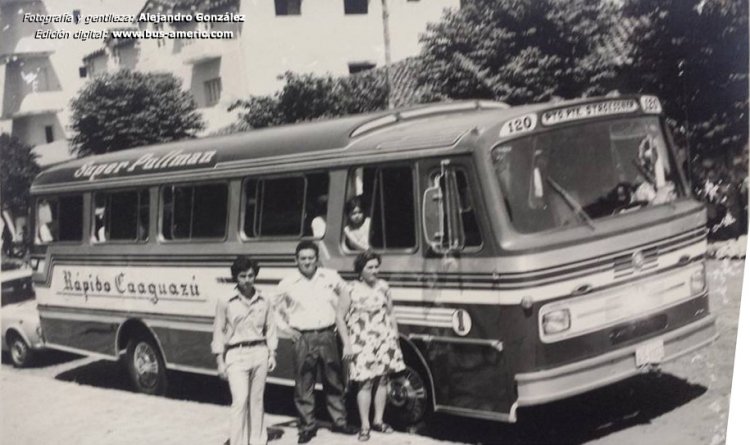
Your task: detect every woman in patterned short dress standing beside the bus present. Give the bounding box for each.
[336,250,406,441]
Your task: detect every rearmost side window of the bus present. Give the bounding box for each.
[35,195,83,244]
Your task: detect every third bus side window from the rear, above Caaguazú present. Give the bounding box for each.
[161,184,229,240]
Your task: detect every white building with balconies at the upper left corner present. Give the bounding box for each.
[0,0,137,165]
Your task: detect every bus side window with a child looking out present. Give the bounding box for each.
[343,165,417,250]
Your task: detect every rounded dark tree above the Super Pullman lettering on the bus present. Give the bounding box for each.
[71,70,204,156]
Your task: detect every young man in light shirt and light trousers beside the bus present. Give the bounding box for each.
[211,256,278,445]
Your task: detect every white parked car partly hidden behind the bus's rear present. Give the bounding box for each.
[0,270,44,368]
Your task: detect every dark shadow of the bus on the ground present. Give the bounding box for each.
[56,360,707,444]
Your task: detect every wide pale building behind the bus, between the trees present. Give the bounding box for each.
[83,0,459,133]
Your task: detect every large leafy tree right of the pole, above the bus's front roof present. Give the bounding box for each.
[419,0,628,104]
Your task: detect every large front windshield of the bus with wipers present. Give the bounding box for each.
[492,117,685,233]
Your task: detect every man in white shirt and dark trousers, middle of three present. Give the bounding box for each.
[275,240,357,443]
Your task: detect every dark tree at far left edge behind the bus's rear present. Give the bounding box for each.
[0,133,40,214]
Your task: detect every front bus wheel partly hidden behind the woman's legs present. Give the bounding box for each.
[386,357,433,429]
